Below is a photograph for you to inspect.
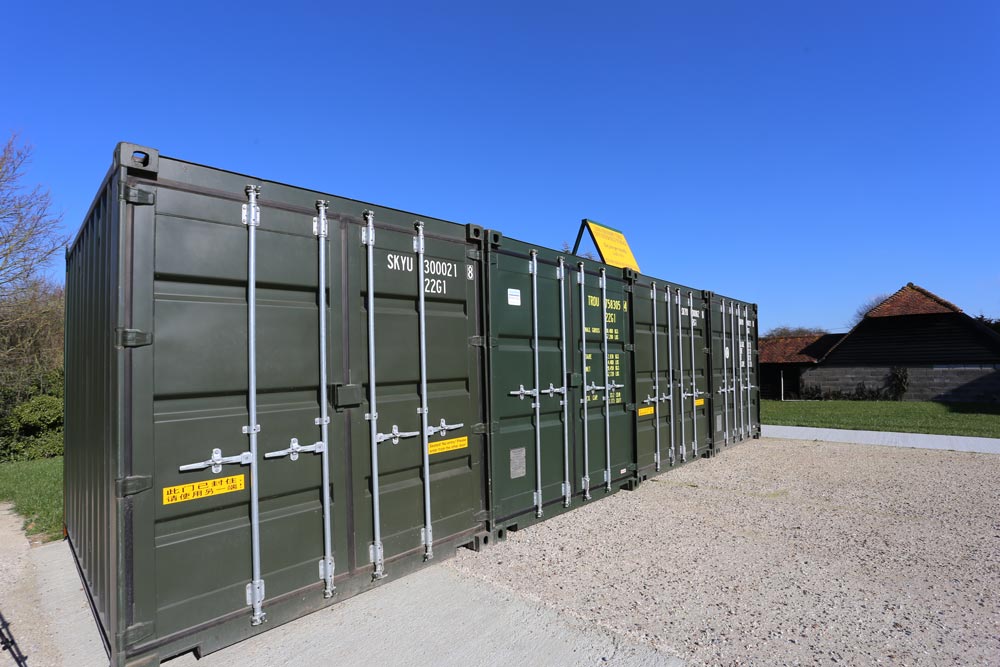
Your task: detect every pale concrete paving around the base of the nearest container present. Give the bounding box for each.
[0,507,685,667]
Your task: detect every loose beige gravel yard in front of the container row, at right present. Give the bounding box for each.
[446,439,1000,665]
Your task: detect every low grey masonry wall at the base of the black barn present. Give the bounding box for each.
[802,365,1000,403]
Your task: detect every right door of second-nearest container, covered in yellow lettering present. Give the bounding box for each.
[570,263,636,493]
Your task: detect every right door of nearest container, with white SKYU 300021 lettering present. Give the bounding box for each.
[348,209,483,578]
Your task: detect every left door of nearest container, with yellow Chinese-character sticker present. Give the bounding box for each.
[138,171,347,637]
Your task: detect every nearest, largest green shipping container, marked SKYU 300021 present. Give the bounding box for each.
[65,144,488,666]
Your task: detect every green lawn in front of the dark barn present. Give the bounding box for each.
[760,401,1000,438]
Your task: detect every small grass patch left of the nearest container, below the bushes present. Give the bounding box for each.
[0,456,63,541]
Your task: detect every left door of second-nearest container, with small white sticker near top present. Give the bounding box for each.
[489,240,579,524]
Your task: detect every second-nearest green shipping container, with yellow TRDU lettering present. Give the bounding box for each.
[486,232,635,539]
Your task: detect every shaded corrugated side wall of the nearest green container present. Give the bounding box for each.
[64,170,122,646]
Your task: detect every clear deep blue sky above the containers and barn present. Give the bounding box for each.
[0,0,1000,330]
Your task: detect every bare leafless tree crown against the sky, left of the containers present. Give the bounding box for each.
[0,134,65,301]
